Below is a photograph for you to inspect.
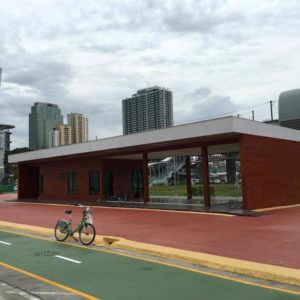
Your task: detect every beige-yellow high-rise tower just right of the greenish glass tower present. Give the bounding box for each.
[68,113,89,144]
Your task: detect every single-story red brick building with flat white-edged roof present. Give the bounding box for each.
[9,117,300,209]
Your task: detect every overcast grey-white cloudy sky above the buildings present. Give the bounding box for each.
[0,0,300,148]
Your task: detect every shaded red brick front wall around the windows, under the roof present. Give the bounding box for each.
[39,157,142,202]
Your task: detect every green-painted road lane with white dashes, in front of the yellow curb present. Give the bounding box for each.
[0,231,300,300]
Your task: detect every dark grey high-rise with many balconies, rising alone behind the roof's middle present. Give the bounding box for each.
[122,86,173,134]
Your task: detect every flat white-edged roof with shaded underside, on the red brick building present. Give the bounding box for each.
[9,117,300,163]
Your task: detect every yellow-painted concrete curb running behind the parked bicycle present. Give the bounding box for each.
[0,221,300,286]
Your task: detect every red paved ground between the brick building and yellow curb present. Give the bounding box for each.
[0,195,300,268]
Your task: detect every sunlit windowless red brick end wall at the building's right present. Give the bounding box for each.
[240,135,300,209]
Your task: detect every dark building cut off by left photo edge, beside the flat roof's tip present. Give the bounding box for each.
[0,124,15,183]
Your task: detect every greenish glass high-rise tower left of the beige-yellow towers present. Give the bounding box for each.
[29,102,63,150]
